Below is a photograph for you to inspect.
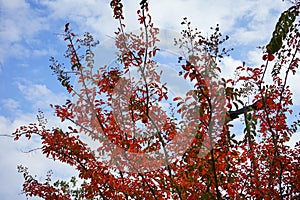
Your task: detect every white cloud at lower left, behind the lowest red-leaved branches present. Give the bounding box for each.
[0,113,77,200]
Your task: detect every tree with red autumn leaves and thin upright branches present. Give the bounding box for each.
[13,0,300,199]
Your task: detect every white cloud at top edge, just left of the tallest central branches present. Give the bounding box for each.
[41,0,118,37]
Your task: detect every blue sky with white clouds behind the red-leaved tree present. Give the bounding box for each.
[0,0,300,200]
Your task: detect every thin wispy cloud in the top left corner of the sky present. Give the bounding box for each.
[0,0,48,63]
